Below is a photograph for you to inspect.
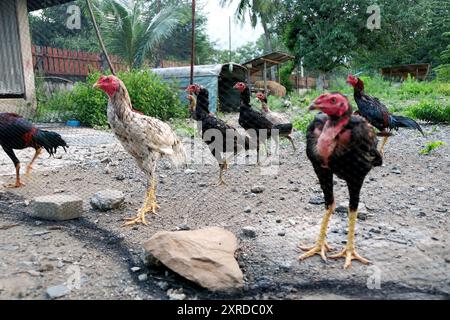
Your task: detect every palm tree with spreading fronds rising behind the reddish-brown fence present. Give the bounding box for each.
[97,0,190,68]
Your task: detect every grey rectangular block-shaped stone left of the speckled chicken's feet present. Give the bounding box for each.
[30,194,83,221]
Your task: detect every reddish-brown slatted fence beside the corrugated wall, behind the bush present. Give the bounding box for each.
[31,46,127,77]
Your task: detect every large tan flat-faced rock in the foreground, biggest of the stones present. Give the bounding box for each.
[144,227,243,291]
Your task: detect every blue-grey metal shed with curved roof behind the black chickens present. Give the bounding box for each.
[152,63,247,112]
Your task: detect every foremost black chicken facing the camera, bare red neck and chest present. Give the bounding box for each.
[299,93,383,268]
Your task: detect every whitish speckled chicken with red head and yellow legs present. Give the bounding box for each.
[94,76,186,226]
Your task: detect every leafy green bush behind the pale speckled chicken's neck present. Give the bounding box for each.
[37,71,188,127]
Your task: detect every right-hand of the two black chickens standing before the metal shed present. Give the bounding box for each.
[234,82,292,165]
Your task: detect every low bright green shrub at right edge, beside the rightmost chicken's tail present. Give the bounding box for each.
[404,99,450,123]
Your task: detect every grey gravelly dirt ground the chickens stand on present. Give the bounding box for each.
[0,118,450,299]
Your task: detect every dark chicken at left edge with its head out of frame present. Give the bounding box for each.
[0,113,68,188]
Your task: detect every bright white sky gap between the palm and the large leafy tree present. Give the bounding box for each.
[199,0,263,49]
